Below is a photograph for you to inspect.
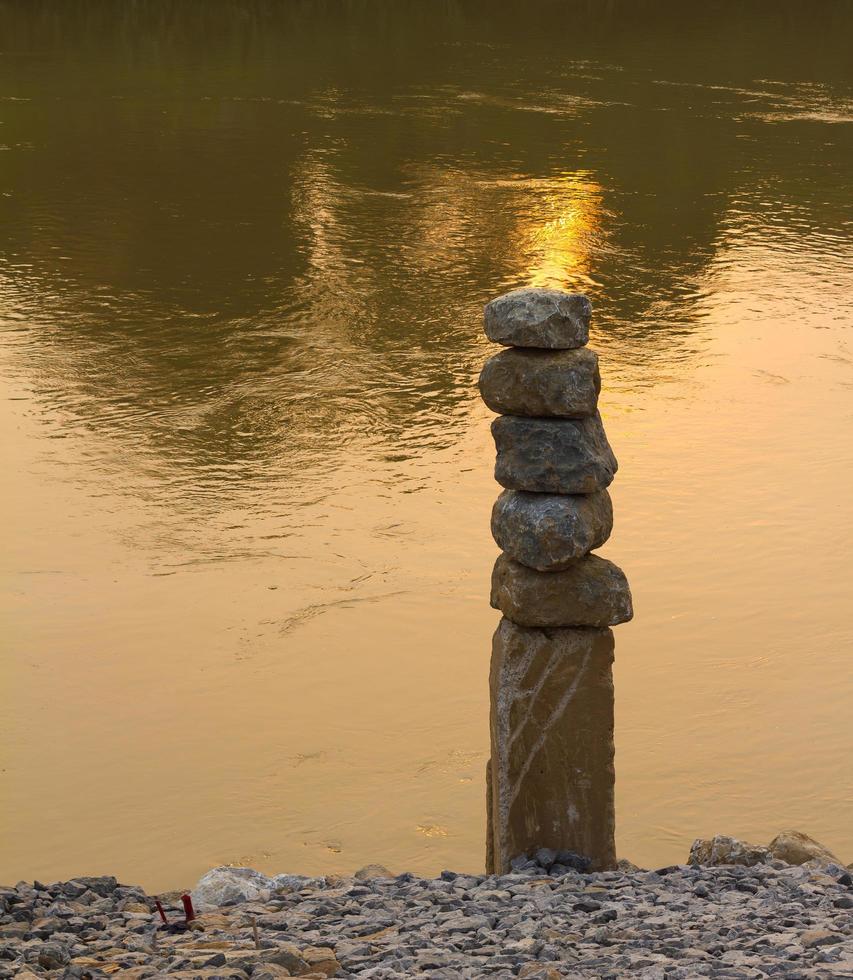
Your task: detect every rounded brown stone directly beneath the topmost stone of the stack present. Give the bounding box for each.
[479,348,601,419]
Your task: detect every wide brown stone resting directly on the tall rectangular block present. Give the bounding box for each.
[491,555,634,629]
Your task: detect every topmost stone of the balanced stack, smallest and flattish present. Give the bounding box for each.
[484,288,592,350]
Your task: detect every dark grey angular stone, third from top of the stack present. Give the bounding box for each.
[492,412,618,493]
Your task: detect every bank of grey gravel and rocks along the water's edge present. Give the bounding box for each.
[0,838,853,980]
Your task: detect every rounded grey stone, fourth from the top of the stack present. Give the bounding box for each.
[492,490,613,572]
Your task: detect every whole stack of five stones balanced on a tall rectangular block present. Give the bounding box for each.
[479,289,633,874]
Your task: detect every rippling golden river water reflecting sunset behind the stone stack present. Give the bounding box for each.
[0,0,853,888]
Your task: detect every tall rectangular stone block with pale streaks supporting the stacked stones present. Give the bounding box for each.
[489,619,616,873]
